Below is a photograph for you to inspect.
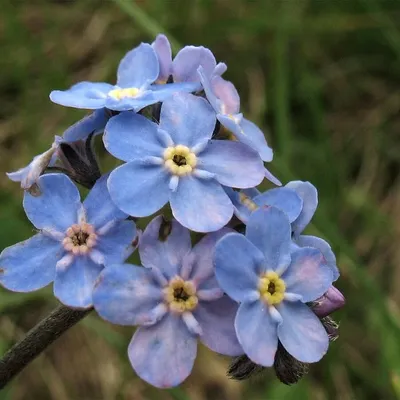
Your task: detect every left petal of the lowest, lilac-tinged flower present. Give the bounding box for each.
[93,264,163,325]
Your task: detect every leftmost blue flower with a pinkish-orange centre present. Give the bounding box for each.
[0,174,136,308]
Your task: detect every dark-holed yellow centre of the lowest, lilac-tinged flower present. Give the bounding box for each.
[164,276,199,313]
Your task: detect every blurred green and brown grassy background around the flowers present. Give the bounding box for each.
[0,0,400,400]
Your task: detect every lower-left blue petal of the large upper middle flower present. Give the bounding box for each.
[108,161,170,217]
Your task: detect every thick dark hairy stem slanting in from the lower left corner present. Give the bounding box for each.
[0,305,92,389]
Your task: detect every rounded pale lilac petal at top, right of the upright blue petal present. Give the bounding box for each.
[172,46,217,82]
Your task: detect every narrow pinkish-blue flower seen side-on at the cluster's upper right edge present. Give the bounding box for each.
[198,67,281,186]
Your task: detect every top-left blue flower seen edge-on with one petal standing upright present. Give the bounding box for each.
[50,43,198,111]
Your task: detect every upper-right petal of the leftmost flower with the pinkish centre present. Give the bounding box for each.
[83,174,127,229]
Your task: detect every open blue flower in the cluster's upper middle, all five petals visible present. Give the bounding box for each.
[103,93,264,232]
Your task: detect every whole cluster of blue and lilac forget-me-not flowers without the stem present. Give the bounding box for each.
[0,35,344,388]
